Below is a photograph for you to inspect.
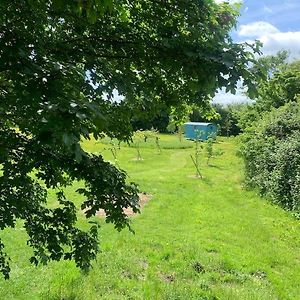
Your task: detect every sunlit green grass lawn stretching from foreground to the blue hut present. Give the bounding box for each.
[0,135,300,300]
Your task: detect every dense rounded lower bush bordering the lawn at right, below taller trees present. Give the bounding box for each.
[241,102,300,212]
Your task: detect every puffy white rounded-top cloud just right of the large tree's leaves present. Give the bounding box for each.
[238,21,279,38]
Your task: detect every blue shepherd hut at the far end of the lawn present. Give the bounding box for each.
[184,122,218,141]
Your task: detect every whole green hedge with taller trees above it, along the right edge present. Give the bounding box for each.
[239,57,300,213]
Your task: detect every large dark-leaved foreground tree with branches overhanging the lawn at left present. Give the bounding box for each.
[0,0,262,278]
